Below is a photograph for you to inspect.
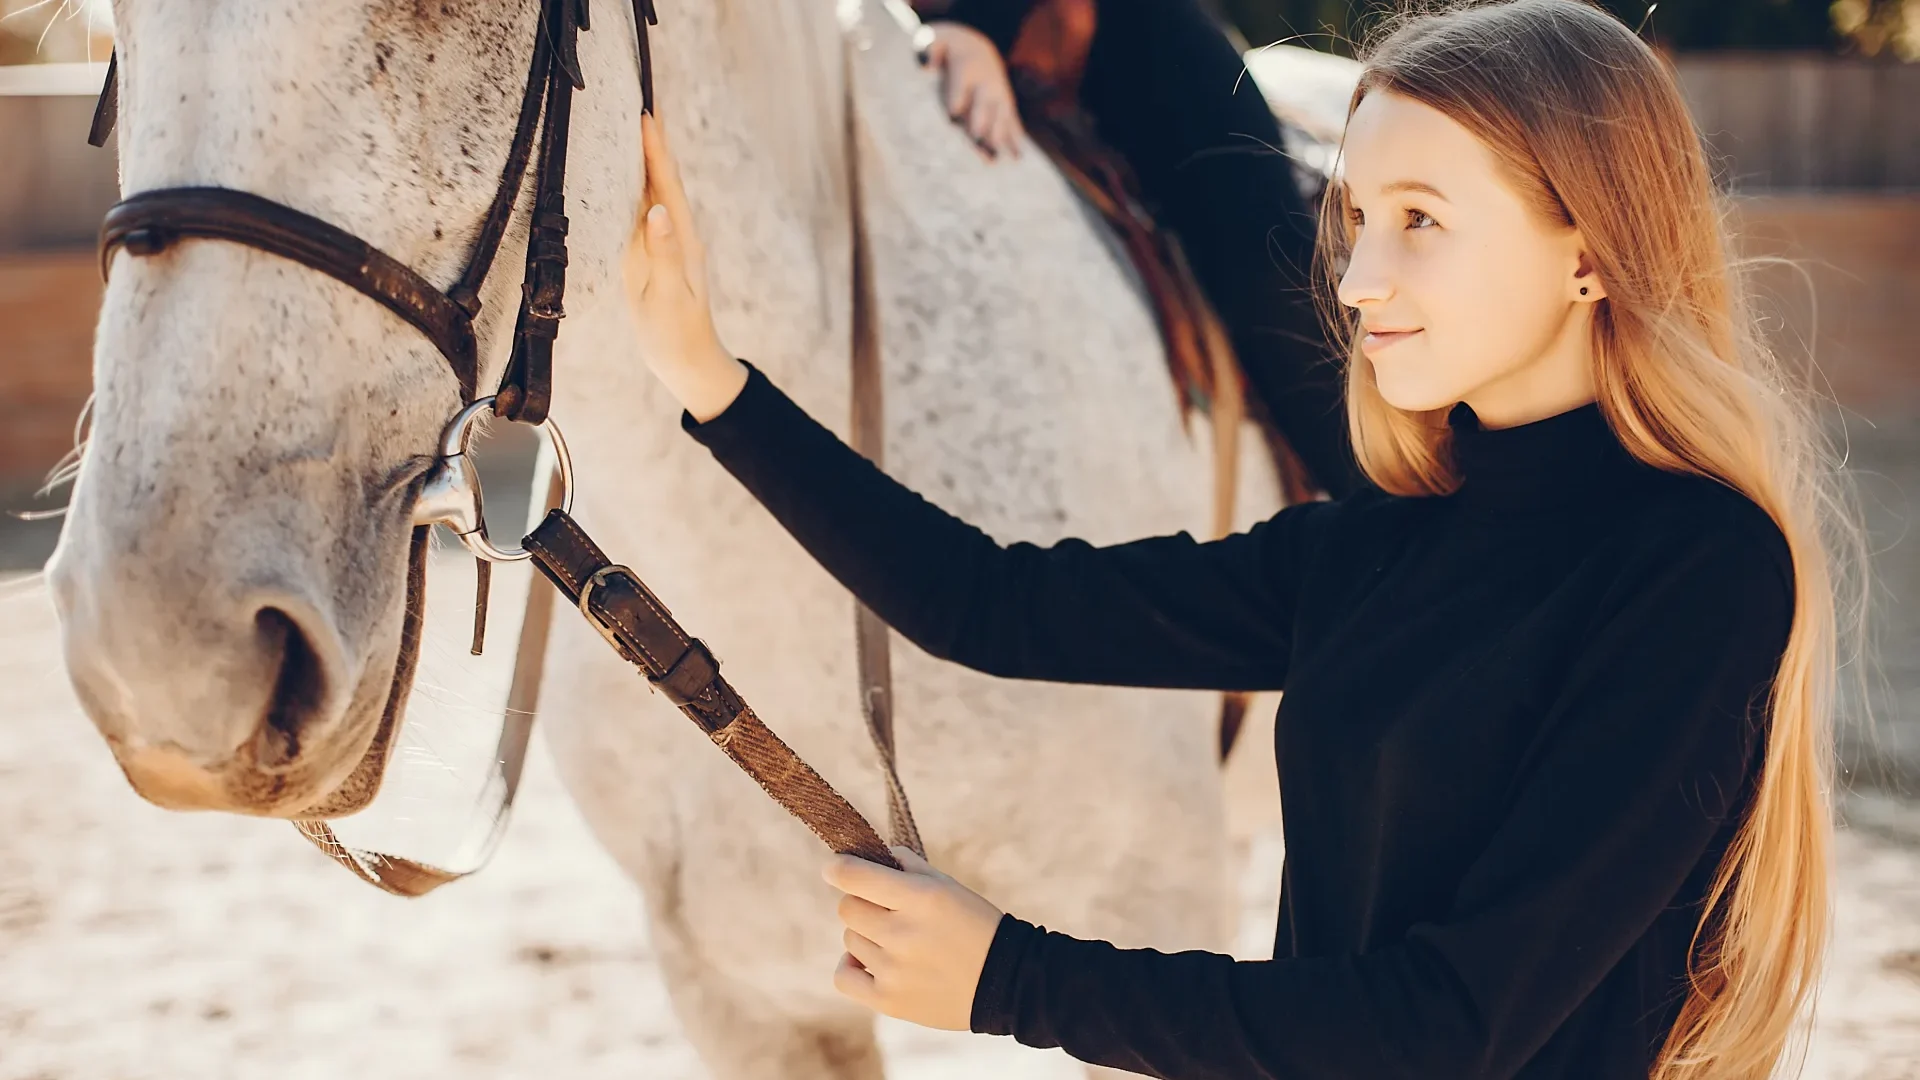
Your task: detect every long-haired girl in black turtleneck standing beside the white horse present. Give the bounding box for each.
[628,0,1836,1080]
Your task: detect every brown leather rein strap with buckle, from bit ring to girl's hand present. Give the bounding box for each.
[526,509,899,869]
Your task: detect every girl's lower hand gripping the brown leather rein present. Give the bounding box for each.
[822,847,1000,1032]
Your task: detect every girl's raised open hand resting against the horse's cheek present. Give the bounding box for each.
[626,115,747,423]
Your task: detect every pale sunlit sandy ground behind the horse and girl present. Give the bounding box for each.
[0,564,1920,1080]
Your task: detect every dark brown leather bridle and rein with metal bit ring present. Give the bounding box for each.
[88,0,920,896]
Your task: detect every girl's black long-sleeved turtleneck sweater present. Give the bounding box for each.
[687,363,1793,1080]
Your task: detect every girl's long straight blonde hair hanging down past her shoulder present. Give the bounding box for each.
[1319,0,1860,1080]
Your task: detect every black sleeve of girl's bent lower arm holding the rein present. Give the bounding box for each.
[972,518,1793,1080]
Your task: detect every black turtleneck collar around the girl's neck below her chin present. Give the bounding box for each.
[1448,402,1644,513]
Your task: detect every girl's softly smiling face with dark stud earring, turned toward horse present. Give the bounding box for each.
[1340,90,1605,427]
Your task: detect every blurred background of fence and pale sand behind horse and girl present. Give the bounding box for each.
[0,0,1920,1080]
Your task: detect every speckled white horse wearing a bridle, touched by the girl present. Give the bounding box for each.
[50,0,1336,1080]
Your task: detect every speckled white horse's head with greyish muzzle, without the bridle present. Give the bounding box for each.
[48,0,639,817]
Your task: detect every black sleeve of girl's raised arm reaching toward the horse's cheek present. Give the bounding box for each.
[682,361,1332,690]
